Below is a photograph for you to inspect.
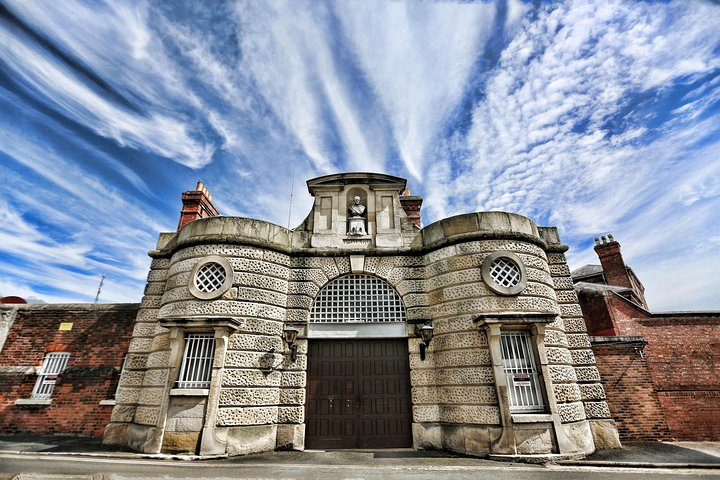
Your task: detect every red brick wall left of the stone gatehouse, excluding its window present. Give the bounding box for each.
[0,304,138,436]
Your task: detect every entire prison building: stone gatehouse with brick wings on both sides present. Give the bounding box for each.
[0,173,720,455]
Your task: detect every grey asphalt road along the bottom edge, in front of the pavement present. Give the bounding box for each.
[0,454,720,480]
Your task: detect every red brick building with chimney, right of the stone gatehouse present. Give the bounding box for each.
[572,235,720,440]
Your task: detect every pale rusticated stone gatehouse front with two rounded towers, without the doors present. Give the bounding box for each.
[105,173,618,455]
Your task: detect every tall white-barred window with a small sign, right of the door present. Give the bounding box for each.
[500,330,545,413]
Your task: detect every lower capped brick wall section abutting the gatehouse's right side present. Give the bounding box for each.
[592,337,670,440]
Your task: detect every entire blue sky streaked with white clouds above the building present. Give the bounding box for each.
[0,0,720,310]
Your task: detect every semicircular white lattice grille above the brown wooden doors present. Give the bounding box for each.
[310,274,405,323]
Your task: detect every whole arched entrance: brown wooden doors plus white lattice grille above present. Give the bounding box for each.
[305,275,412,449]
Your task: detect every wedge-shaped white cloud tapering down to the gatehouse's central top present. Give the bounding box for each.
[338,1,495,180]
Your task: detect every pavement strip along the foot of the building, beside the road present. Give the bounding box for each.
[0,435,720,471]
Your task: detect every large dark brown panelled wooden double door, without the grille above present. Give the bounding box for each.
[305,339,412,449]
